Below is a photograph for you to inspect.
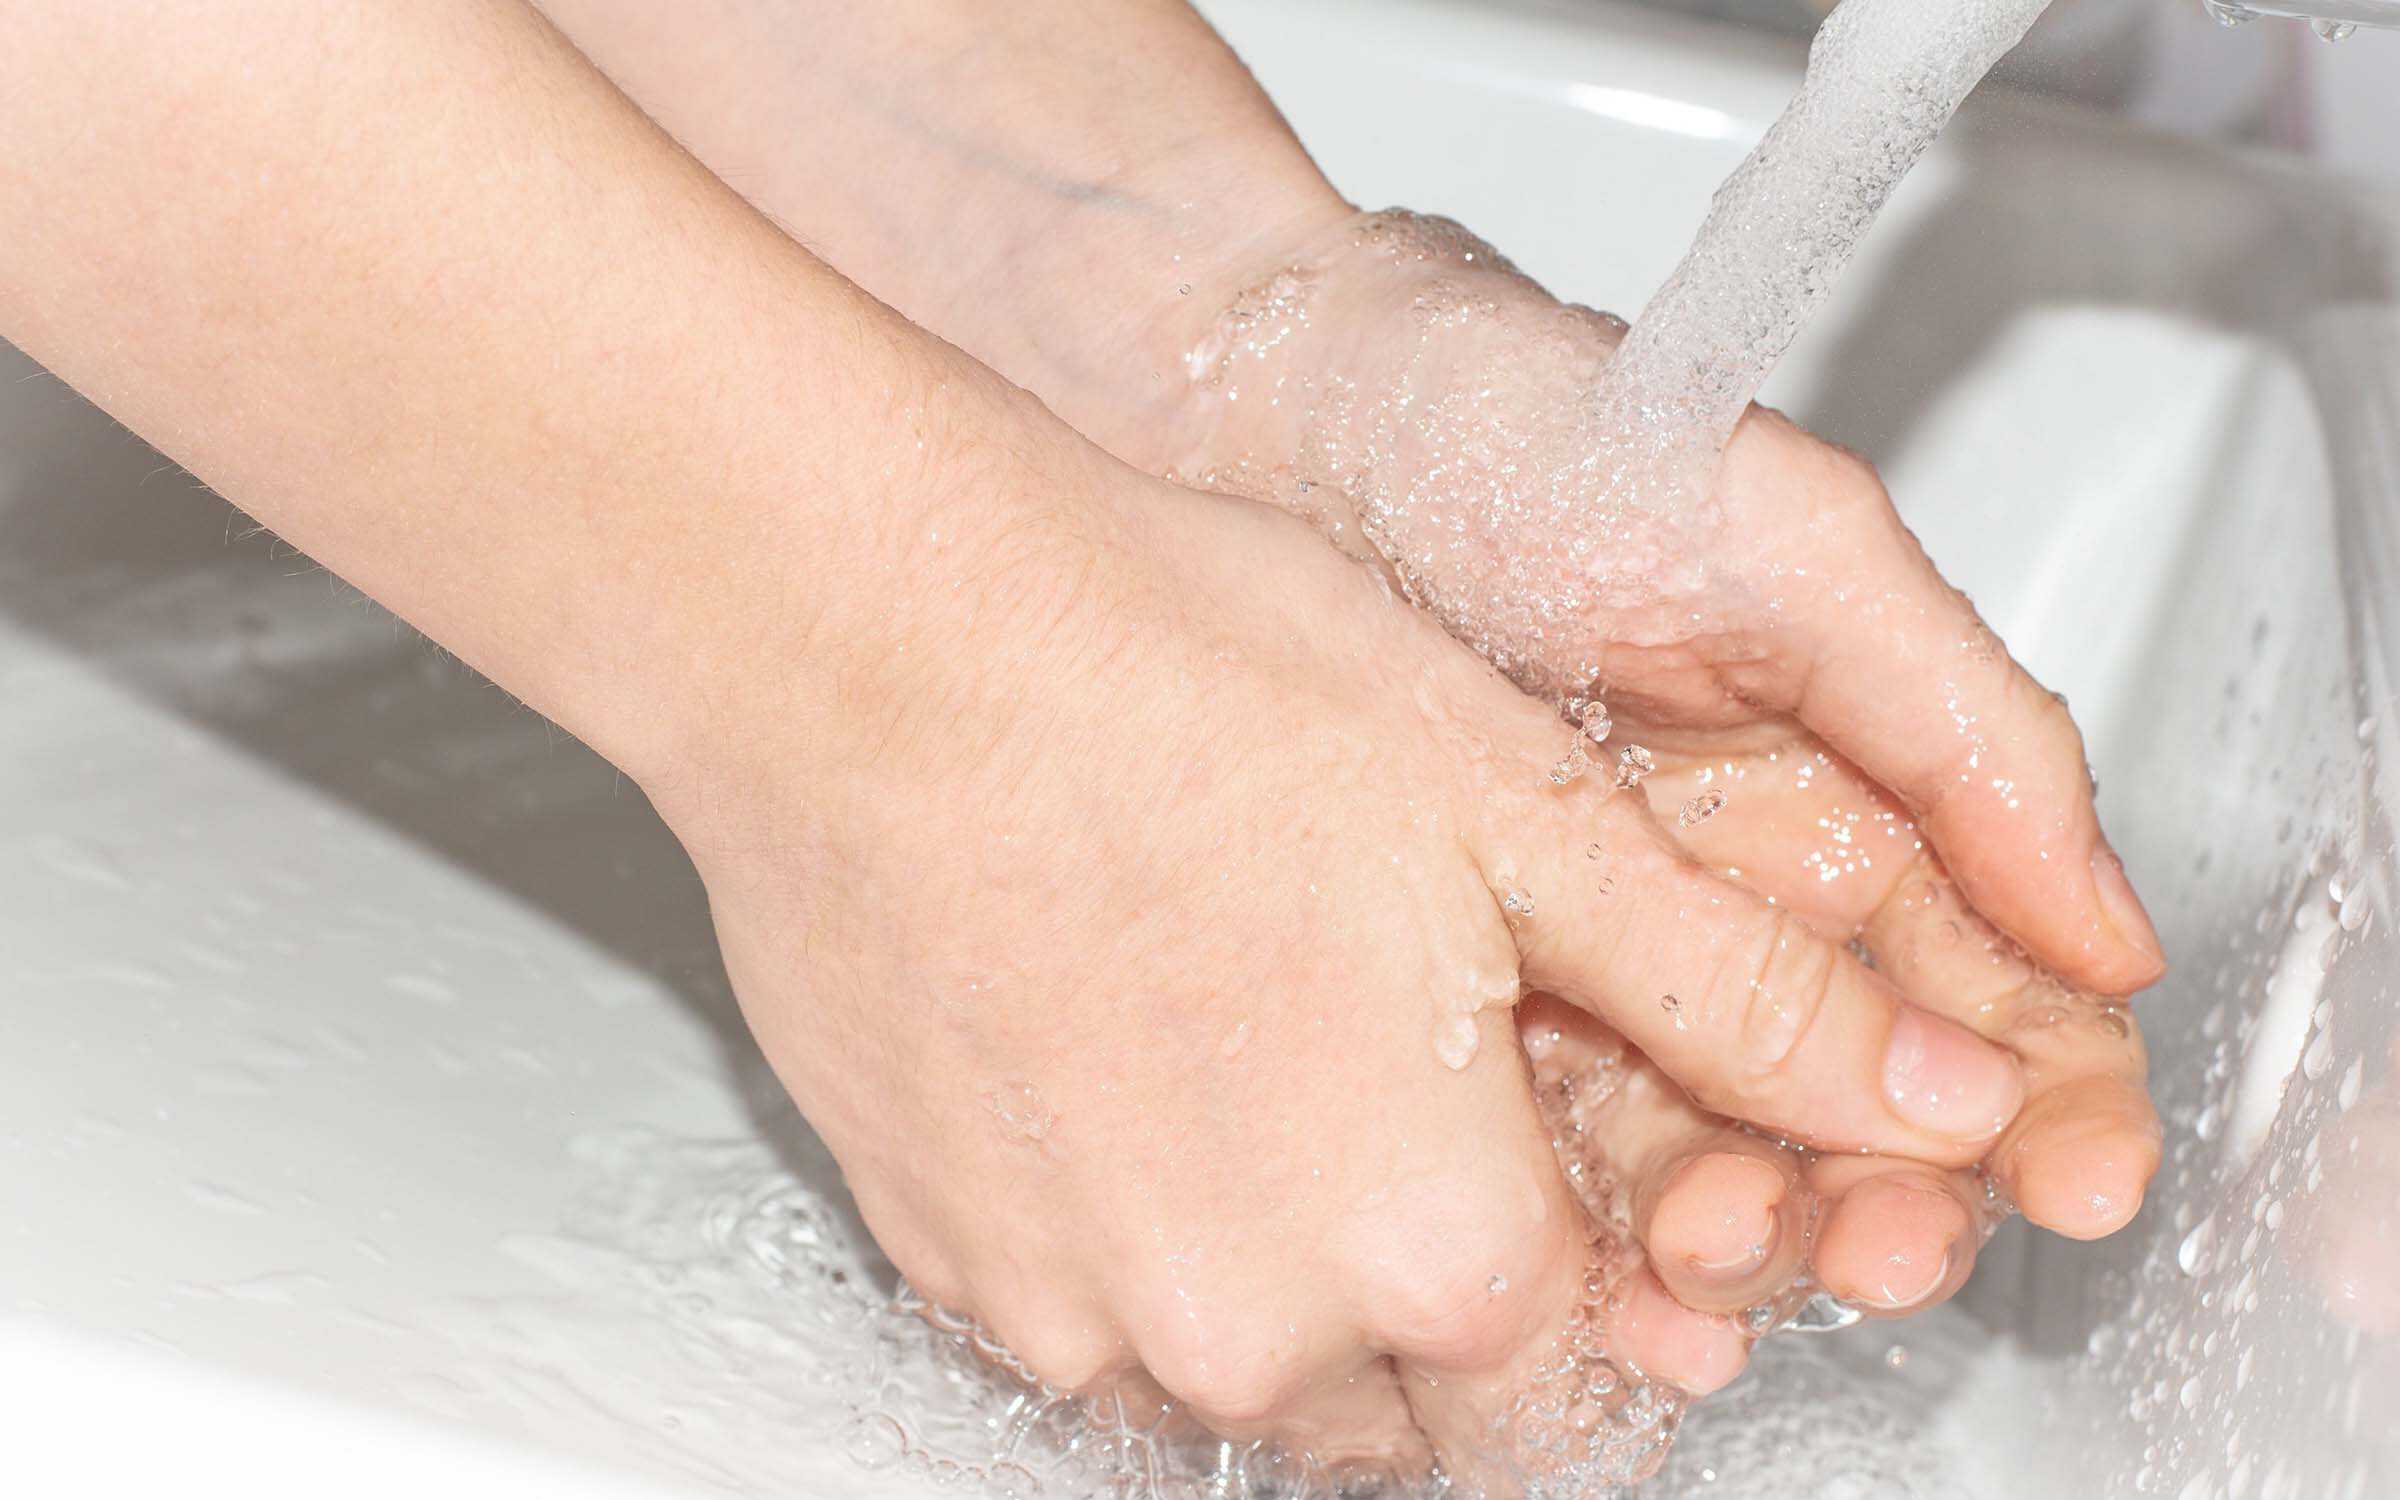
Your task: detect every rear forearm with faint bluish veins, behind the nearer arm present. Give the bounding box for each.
[542,0,1346,466]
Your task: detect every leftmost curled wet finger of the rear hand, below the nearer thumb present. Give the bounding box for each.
[1517,994,1814,1305]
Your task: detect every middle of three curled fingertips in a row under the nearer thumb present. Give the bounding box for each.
[1807,1157,1990,1318]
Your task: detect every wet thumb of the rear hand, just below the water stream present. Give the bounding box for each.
[1721,415,2165,994]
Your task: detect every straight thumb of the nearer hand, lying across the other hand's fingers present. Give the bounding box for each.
[1481,790,2023,1166]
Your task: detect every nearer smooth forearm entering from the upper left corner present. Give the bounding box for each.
[0,0,1051,796]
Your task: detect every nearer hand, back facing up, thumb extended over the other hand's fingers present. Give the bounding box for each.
[650,436,2021,1471]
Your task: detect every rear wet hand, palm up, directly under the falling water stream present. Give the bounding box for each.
[1145,216,2162,1308]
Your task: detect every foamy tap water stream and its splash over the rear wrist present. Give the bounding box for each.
[1176,0,2047,705]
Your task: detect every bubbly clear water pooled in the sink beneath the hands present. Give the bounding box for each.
[454,1130,2014,1500]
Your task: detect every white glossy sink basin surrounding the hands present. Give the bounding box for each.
[0,0,2400,1500]
